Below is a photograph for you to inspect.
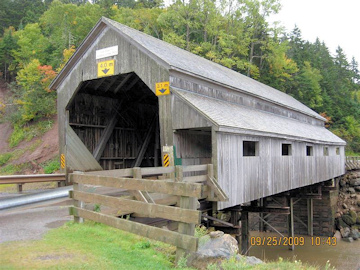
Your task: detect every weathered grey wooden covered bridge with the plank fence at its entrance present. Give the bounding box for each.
[51,18,345,258]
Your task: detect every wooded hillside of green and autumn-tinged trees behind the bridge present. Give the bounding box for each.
[0,0,360,175]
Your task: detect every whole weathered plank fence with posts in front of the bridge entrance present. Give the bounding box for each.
[70,164,227,259]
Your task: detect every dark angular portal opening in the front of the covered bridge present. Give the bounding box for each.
[67,72,161,170]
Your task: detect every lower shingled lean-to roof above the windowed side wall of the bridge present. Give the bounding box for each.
[173,89,345,145]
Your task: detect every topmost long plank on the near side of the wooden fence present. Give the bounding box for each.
[70,173,207,198]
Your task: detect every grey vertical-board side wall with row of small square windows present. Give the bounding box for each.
[217,133,345,209]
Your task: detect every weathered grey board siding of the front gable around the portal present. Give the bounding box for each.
[57,27,173,173]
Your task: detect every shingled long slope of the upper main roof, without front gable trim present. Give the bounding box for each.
[102,18,325,120]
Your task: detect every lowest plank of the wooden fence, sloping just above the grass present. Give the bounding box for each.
[73,207,198,251]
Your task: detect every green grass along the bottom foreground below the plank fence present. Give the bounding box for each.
[0,221,329,270]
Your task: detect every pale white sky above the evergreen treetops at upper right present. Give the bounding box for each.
[270,0,360,65]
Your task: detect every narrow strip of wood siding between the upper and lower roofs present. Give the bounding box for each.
[170,71,324,127]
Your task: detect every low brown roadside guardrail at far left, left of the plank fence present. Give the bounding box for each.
[0,174,66,192]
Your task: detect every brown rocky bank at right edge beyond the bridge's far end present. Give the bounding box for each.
[335,171,360,242]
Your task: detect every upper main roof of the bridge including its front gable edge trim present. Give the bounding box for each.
[50,17,325,121]
